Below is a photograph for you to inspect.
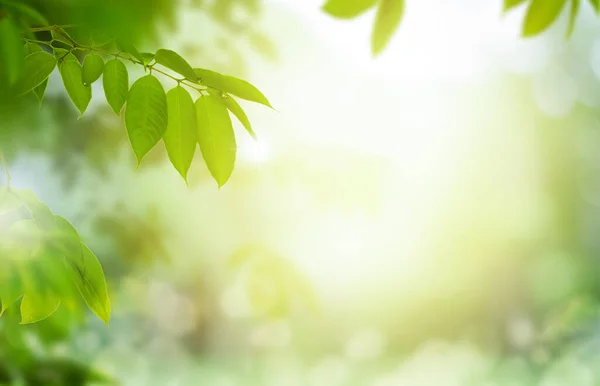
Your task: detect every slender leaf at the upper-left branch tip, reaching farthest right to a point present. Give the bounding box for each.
[194,68,273,108]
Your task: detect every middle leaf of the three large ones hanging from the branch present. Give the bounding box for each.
[163,86,198,182]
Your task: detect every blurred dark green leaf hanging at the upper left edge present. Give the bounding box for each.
[0,17,23,84]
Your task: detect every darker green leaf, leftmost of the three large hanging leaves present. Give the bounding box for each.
[125,75,168,166]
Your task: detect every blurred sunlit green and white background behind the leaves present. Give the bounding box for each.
[0,0,600,386]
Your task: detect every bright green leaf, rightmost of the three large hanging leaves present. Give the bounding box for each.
[196,95,237,188]
